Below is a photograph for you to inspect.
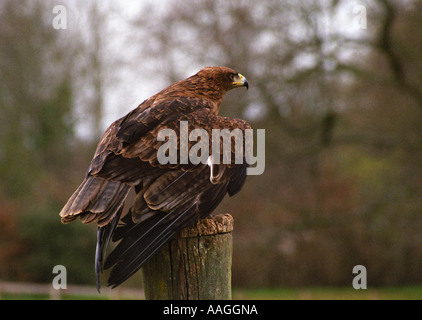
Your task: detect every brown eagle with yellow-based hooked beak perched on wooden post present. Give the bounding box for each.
[60,67,251,290]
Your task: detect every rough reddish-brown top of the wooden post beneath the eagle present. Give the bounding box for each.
[181,213,234,238]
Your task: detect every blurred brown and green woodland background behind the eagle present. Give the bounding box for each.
[0,0,422,287]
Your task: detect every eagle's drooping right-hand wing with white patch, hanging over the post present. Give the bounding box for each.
[99,110,248,286]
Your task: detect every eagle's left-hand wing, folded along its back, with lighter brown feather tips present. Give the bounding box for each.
[60,96,214,226]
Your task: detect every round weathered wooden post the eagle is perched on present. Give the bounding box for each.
[142,214,233,300]
